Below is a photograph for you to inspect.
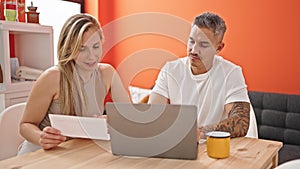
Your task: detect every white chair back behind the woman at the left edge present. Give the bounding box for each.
[0,103,26,160]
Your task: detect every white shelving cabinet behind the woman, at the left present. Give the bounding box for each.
[0,21,54,112]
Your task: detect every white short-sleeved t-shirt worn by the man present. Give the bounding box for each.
[152,56,250,127]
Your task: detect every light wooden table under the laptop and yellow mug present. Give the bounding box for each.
[0,137,282,169]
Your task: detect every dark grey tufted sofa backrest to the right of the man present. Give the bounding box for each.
[249,91,300,145]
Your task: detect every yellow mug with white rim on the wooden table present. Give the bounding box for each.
[206,131,230,158]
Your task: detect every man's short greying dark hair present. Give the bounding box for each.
[193,12,226,42]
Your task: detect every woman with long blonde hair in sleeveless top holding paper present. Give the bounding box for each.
[19,14,130,154]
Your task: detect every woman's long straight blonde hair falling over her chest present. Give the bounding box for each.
[57,14,104,115]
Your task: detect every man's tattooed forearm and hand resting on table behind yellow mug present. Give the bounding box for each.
[198,102,250,138]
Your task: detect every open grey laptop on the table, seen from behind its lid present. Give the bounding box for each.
[106,102,198,160]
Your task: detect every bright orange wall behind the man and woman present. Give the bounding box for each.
[87,0,300,94]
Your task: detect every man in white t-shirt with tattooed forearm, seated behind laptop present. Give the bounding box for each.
[148,12,250,138]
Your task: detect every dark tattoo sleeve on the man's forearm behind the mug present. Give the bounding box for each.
[216,102,250,137]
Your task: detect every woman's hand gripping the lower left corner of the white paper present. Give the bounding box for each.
[39,126,67,150]
